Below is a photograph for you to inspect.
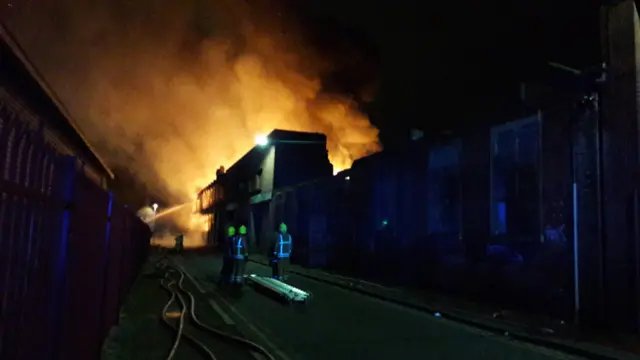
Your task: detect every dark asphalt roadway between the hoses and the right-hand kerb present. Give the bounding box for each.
[180,255,578,360]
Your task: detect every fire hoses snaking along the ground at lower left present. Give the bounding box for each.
[156,256,275,360]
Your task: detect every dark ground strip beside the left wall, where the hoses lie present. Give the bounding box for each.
[102,259,262,360]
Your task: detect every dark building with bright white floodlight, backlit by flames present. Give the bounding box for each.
[197,130,333,250]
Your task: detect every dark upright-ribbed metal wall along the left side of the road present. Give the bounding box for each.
[0,99,150,360]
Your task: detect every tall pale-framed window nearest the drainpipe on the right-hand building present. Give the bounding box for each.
[490,117,541,241]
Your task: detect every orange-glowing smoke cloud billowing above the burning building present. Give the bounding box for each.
[3,0,379,238]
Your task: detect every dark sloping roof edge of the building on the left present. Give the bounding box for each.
[0,22,114,179]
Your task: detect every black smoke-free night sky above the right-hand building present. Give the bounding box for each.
[290,0,600,143]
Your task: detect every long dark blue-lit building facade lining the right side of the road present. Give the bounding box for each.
[198,1,640,332]
